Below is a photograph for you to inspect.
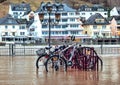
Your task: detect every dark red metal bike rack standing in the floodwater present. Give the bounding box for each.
[66,47,103,70]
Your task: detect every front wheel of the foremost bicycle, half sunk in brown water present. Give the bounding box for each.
[45,55,67,72]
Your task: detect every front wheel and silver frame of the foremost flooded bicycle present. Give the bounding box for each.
[45,44,80,72]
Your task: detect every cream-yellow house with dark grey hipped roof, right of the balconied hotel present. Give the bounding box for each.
[83,13,111,38]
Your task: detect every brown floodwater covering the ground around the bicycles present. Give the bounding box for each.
[0,56,120,85]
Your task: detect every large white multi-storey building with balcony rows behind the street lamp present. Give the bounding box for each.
[36,2,85,39]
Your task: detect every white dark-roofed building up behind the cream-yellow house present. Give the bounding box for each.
[78,5,108,20]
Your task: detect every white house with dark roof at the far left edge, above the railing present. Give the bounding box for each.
[0,14,28,43]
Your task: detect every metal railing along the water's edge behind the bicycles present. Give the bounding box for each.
[0,44,120,56]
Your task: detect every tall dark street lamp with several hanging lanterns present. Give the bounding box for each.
[38,2,60,53]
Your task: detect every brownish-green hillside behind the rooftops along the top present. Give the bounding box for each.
[0,0,120,18]
